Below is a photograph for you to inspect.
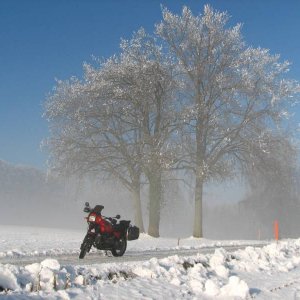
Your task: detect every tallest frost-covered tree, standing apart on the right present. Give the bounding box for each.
[156,6,299,237]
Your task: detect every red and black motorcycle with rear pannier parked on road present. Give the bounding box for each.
[79,202,139,259]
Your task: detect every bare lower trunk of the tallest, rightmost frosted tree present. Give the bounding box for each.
[193,176,203,238]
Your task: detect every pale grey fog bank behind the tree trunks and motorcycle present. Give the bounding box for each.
[0,161,300,239]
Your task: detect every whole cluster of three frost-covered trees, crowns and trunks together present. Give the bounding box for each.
[45,6,300,237]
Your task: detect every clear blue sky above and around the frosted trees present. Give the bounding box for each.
[0,0,300,169]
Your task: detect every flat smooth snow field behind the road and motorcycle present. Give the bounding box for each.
[0,225,261,259]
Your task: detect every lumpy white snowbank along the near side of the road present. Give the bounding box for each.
[0,239,300,299]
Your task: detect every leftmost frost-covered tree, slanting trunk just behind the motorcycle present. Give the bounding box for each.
[45,58,144,232]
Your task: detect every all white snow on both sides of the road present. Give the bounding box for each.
[0,227,300,299]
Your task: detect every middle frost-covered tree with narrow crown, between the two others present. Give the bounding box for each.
[122,30,179,237]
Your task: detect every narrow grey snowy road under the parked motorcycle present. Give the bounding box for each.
[0,242,267,266]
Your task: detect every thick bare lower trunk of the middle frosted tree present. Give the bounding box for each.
[148,173,162,237]
